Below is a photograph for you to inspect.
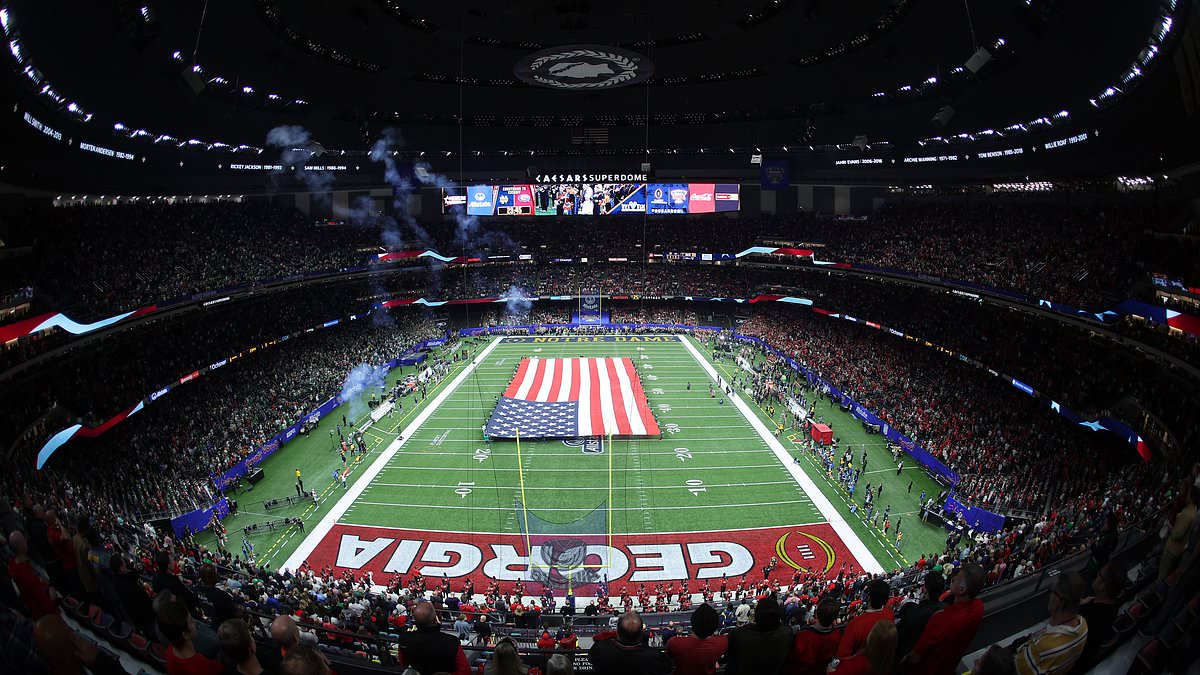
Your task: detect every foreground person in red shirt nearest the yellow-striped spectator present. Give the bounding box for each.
[900,562,984,675]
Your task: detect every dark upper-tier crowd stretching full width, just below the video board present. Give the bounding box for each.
[0,201,1200,319]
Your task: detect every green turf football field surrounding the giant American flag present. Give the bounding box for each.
[200,326,943,578]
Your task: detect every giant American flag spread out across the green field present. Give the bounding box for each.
[487,358,660,438]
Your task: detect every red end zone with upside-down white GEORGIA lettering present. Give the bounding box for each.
[300,524,862,587]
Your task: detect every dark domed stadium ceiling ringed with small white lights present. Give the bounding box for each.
[0,0,1184,190]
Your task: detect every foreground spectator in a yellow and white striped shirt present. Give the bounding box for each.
[1015,572,1087,675]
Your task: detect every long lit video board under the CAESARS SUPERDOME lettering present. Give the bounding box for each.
[442,183,740,216]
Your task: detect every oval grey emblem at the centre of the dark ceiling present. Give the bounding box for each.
[512,44,654,90]
